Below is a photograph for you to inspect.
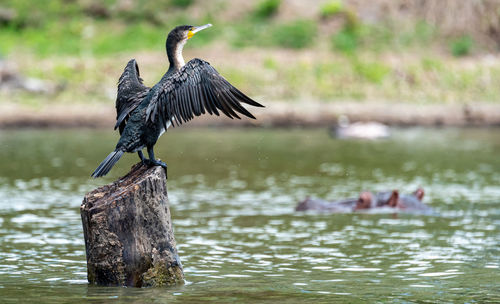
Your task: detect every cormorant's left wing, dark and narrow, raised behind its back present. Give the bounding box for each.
[115,59,151,134]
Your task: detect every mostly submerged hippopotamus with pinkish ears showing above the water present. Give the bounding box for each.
[295,188,432,213]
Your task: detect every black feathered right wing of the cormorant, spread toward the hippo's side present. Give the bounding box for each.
[146,58,263,128]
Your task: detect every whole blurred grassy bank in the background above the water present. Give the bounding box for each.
[0,0,500,126]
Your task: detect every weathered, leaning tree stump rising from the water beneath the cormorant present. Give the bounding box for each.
[80,163,184,287]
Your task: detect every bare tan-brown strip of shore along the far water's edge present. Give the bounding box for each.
[0,101,500,129]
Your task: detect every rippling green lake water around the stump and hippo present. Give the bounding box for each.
[0,128,500,303]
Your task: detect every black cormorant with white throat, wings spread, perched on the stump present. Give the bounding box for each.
[92,24,263,178]
